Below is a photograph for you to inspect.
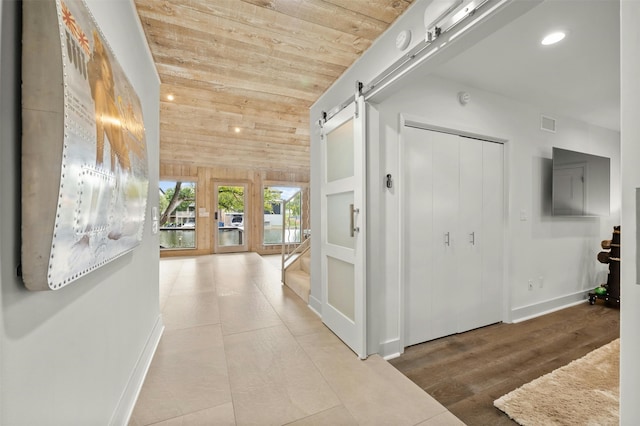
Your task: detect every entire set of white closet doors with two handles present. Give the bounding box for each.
[401,122,504,346]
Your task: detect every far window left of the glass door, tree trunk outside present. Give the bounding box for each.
[159,181,196,250]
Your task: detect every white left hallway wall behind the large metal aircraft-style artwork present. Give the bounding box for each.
[0,0,162,426]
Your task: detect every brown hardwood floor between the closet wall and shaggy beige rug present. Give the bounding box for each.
[390,302,620,426]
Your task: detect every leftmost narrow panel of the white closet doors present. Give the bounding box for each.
[402,127,434,346]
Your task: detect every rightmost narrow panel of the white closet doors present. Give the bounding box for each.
[482,142,505,324]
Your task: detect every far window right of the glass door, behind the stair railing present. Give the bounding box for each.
[263,186,302,245]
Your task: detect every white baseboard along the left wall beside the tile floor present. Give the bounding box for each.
[109,315,164,426]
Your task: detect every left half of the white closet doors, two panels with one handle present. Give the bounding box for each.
[402,127,459,345]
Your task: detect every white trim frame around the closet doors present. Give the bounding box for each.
[398,113,511,354]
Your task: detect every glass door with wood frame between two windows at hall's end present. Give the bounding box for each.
[213,182,251,253]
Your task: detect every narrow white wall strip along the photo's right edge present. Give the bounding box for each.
[620,0,640,426]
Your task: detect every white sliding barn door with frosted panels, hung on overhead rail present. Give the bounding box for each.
[321,97,367,359]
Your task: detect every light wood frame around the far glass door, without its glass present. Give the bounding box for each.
[211,178,253,254]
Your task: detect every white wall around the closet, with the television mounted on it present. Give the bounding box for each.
[376,76,620,355]
